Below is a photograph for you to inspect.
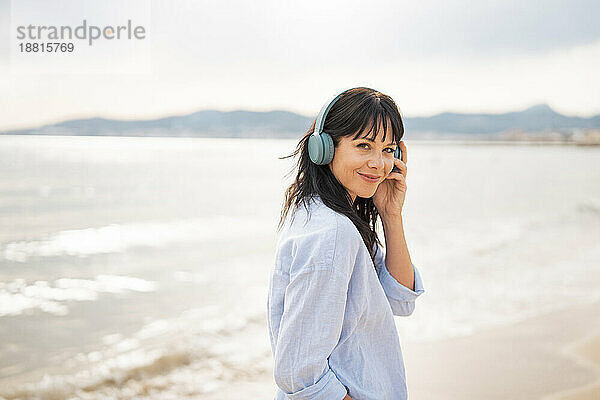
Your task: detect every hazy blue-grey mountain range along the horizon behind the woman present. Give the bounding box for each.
[0,104,600,138]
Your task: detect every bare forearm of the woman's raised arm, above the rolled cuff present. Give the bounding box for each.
[382,216,415,290]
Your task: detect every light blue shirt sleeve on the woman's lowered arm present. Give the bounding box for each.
[274,266,348,400]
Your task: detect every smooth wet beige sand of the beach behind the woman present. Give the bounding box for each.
[203,302,600,400]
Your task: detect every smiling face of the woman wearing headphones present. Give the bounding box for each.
[329,124,396,202]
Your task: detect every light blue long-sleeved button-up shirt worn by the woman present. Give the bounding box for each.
[267,193,424,400]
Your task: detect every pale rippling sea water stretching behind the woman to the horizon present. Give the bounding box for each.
[0,136,600,399]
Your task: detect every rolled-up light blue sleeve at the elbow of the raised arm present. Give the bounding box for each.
[375,243,425,316]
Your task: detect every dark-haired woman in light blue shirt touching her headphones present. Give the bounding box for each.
[267,87,424,400]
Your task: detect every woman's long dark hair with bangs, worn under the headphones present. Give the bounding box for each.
[277,87,404,264]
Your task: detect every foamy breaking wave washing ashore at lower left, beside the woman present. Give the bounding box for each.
[0,306,271,400]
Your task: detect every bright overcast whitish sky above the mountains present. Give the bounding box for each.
[0,0,600,131]
